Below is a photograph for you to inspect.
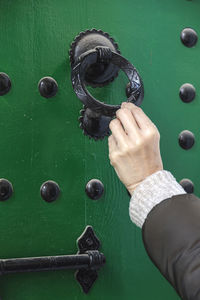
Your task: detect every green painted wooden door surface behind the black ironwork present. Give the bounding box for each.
[0,0,200,300]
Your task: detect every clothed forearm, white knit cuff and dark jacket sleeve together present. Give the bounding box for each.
[129,170,200,300]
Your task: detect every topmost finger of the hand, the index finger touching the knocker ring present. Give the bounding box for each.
[121,102,155,130]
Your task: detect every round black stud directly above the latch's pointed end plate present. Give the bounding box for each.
[85,179,104,200]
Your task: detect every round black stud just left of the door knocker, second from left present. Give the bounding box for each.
[38,77,58,98]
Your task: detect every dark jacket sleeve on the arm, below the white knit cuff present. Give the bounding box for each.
[142,194,200,300]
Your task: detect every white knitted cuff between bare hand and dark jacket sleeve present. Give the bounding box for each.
[129,170,186,228]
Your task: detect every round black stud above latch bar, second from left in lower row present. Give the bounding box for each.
[40,180,60,202]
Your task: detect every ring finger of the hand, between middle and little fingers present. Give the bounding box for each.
[109,118,126,147]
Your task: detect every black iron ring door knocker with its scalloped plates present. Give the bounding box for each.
[70,29,144,140]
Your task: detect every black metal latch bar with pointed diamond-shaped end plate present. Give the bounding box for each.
[0,226,105,293]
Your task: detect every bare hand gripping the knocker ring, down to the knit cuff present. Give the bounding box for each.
[108,102,163,196]
